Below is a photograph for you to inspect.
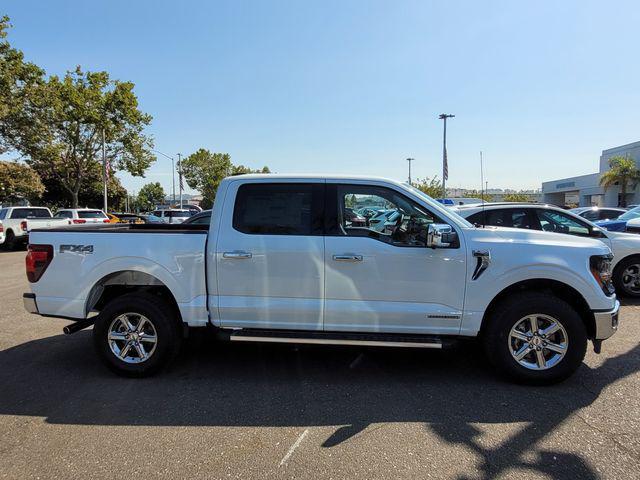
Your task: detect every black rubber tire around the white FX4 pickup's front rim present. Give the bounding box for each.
[482,292,587,385]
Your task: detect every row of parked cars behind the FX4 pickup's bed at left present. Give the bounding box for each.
[0,206,199,250]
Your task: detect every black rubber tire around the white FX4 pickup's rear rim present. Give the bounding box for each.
[93,293,182,377]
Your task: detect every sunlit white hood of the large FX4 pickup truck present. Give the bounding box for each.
[473,227,610,254]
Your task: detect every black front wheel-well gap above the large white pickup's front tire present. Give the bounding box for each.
[480,278,596,338]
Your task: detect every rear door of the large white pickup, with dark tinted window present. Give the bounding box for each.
[216,181,325,330]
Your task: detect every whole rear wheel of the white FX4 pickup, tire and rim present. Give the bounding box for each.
[93,293,181,377]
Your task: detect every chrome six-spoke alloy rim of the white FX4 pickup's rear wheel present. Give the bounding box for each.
[107,313,158,363]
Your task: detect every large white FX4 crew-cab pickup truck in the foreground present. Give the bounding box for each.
[24,175,619,383]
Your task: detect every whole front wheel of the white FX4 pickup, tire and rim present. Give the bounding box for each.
[483,292,587,385]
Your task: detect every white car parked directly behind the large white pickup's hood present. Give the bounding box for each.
[457,203,640,297]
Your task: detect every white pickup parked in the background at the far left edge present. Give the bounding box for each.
[0,207,68,249]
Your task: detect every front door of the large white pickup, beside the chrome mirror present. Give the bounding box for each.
[324,182,466,334]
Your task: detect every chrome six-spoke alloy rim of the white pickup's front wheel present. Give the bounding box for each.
[508,313,569,370]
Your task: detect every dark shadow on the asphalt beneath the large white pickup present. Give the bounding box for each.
[0,332,640,479]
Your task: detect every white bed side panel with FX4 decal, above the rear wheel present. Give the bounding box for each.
[30,230,208,326]
